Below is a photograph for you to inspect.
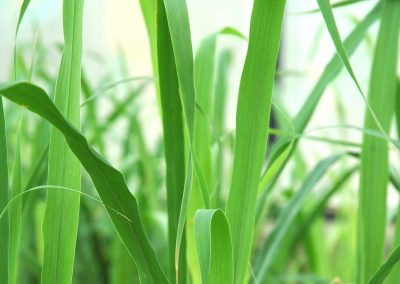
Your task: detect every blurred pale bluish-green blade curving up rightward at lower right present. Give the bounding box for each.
[256,154,344,283]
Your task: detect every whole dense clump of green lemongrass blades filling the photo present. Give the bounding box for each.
[0,0,400,284]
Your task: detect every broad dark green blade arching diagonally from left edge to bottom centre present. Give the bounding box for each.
[0,83,168,284]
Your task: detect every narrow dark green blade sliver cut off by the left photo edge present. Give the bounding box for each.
[0,98,9,283]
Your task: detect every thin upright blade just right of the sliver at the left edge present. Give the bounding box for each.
[8,125,22,284]
